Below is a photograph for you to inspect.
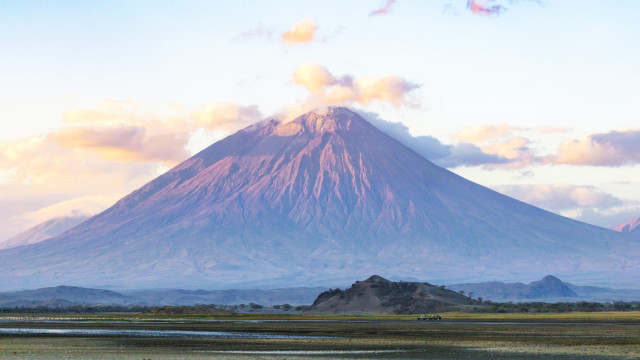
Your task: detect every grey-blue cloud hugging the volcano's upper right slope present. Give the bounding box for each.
[359,111,508,168]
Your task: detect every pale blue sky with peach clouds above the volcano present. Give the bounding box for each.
[0,0,640,241]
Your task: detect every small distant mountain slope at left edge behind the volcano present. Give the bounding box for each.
[0,216,89,250]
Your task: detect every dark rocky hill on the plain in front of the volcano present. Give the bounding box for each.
[308,275,472,314]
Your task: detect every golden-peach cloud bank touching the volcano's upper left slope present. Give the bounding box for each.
[47,100,262,165]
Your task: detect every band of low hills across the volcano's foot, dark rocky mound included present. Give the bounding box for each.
[0,276,640,313]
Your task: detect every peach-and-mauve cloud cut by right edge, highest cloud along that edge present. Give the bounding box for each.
[549,129,640,166]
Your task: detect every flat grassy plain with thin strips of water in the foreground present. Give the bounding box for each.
[0,312,640,360]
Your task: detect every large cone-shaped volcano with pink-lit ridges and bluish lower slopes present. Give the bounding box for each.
[0,108,640,289]
